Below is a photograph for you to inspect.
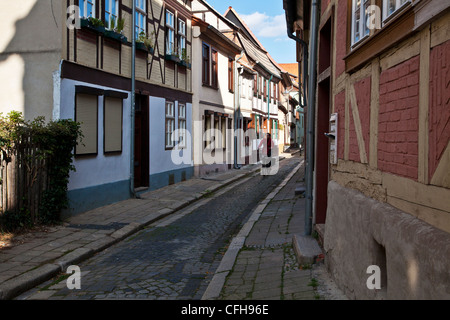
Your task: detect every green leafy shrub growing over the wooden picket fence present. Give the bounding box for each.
[0,111,81,229]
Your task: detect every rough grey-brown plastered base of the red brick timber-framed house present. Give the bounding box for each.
[324,181,450,299]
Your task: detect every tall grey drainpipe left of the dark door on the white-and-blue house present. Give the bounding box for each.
[130,1,136,198]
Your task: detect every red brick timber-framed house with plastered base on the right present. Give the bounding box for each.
[285,0,450,299]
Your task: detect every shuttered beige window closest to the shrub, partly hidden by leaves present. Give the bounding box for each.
[75,93,98,155]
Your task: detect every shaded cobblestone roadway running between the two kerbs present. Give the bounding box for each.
[18,156,306,300]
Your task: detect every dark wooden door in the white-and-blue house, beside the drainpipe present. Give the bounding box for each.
[134,94,150,188]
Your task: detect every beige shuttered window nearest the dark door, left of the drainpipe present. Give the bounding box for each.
[103,97,123,153]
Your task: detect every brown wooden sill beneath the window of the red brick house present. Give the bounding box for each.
[343,6,414,73]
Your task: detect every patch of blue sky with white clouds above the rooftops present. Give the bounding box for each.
[206,0,295,63]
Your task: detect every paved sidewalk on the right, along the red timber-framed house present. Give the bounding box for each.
[220,167,321,300]
